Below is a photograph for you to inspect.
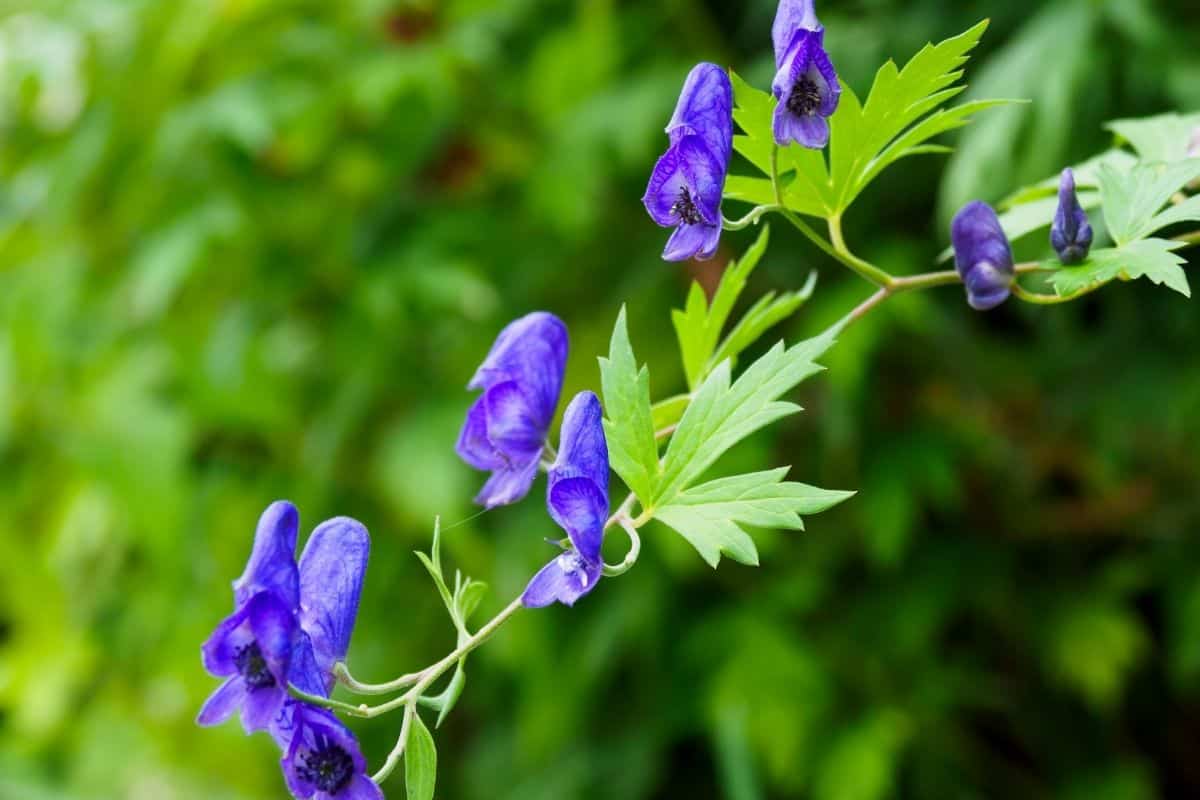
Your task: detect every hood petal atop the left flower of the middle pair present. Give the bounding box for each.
[467,311,568,427]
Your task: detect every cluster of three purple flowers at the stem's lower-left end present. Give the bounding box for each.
[197,500,383,800]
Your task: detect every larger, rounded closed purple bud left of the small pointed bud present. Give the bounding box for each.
[950,200,1015,311]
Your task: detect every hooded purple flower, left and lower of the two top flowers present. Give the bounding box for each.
[642,64,733,261]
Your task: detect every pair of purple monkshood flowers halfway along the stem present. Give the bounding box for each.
[458,311,614,608]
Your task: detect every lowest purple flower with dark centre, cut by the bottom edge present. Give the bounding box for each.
[280,704,383,800]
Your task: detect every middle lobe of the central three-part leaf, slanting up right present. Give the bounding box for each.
[657,330,835,509]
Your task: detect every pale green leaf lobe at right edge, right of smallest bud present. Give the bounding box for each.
[1099,158,1200,245]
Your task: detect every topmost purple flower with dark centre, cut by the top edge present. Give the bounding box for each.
[770,0,841,150]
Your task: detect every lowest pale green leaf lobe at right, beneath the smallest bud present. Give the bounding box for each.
[1050,239,1192,297]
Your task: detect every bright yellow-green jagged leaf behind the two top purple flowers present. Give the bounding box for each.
[726,20,1014,217]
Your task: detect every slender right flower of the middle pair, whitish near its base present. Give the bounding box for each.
[521,392,608,608]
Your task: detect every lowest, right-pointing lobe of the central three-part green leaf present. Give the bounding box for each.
[654,467,853,567]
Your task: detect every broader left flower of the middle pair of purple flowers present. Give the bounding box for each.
[456,311,568,509]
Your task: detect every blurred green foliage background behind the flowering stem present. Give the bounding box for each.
[0,0,1200,800]
